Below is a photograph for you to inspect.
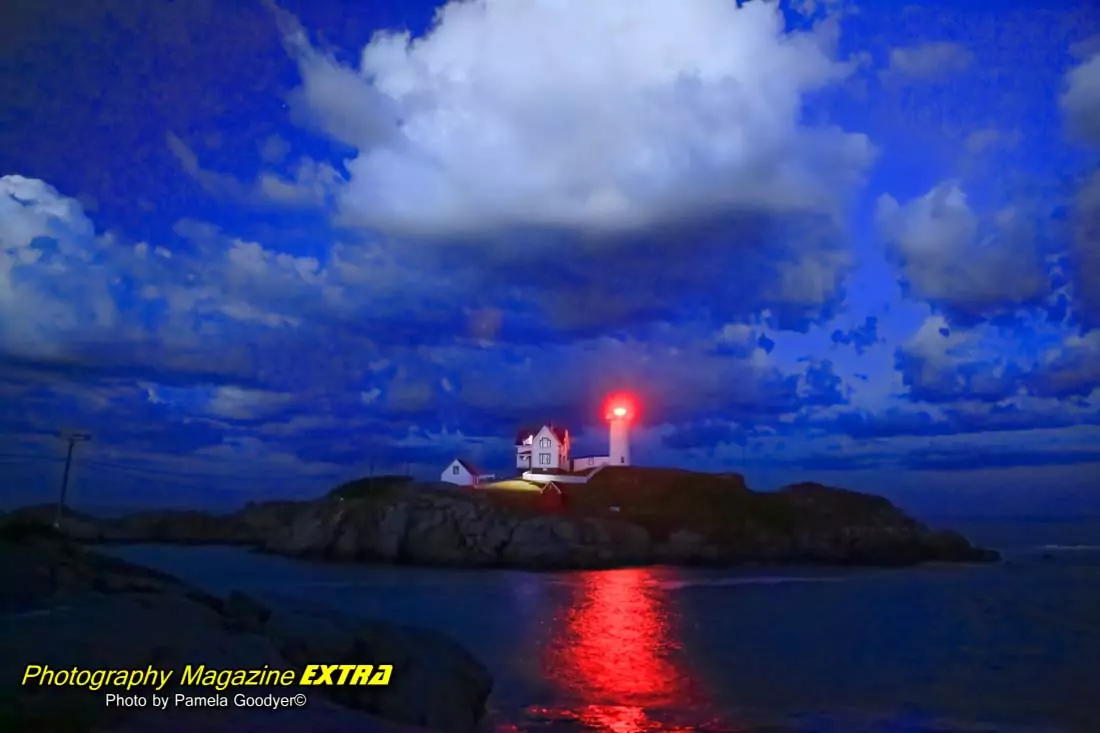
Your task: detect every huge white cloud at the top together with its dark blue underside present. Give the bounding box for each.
[255,0,873,340]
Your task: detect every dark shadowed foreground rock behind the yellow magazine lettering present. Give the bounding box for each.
[0,523,492,733]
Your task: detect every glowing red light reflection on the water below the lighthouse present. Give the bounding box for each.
[528,568,699,733]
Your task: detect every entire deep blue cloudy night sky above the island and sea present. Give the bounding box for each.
[0,0,1100,515]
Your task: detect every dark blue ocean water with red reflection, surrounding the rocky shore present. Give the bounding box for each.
[101,522,1100,733]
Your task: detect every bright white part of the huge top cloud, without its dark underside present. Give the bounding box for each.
[283,0,873,234]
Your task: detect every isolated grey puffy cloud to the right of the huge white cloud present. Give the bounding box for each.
[876,182,1049,318]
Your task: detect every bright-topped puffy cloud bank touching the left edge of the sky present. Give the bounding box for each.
[0,176,349,382]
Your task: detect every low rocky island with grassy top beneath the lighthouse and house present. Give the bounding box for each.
[0,467,999,569]
